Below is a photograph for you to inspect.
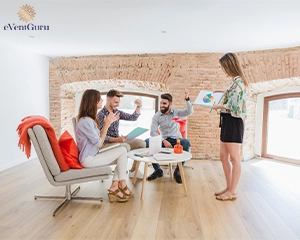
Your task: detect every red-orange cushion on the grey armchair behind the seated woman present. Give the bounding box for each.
[58,130,83,169]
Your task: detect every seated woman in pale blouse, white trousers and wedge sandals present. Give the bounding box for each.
[75,89,134,202]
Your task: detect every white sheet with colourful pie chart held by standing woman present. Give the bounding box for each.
[194,90,224,108]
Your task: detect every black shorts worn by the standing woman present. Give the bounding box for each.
[220,113,244,143]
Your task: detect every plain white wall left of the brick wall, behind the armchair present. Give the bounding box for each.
[0,42,49,171]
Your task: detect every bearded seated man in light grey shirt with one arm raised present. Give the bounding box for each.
[145,89,194,183]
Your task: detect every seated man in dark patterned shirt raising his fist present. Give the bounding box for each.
[97,89,146,179]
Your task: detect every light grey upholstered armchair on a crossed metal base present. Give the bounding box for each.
[28,125,112,217]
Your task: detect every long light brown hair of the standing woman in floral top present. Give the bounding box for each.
[219,53,248,87]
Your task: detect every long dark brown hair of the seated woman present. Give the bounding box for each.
[77,89,101,127]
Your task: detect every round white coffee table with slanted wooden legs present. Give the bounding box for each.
[127,148,192,199]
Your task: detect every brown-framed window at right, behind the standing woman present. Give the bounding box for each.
[262,93,300,163]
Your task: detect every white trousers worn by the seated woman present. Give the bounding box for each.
[81,146,127,180]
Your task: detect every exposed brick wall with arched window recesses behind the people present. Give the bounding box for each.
[50,47,300,159]
